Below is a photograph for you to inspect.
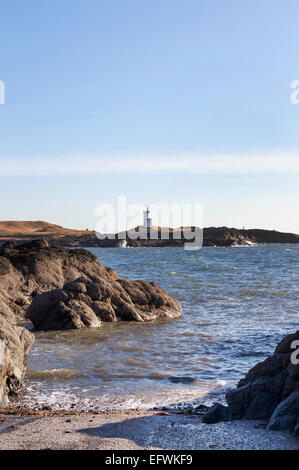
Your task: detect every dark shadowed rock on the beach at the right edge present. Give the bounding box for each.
[204,331,299,434]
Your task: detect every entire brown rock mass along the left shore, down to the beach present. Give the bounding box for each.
[0,240,182,406]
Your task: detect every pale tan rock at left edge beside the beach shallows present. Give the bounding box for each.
[0,300,34,407]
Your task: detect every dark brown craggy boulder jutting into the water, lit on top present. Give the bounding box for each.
[28,275,181,330]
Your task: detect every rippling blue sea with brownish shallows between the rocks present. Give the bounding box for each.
[21,244,299,411]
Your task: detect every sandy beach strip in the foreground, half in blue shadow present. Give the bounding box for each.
[0,410,299,450]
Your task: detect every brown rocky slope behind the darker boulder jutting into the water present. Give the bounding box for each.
[0,240,118,319]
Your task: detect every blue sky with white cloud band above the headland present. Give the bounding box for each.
[0,0,299,233]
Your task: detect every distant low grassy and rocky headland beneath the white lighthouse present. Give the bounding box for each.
[0,221,299,248]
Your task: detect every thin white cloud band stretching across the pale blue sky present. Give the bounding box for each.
[0,153,299,176]
